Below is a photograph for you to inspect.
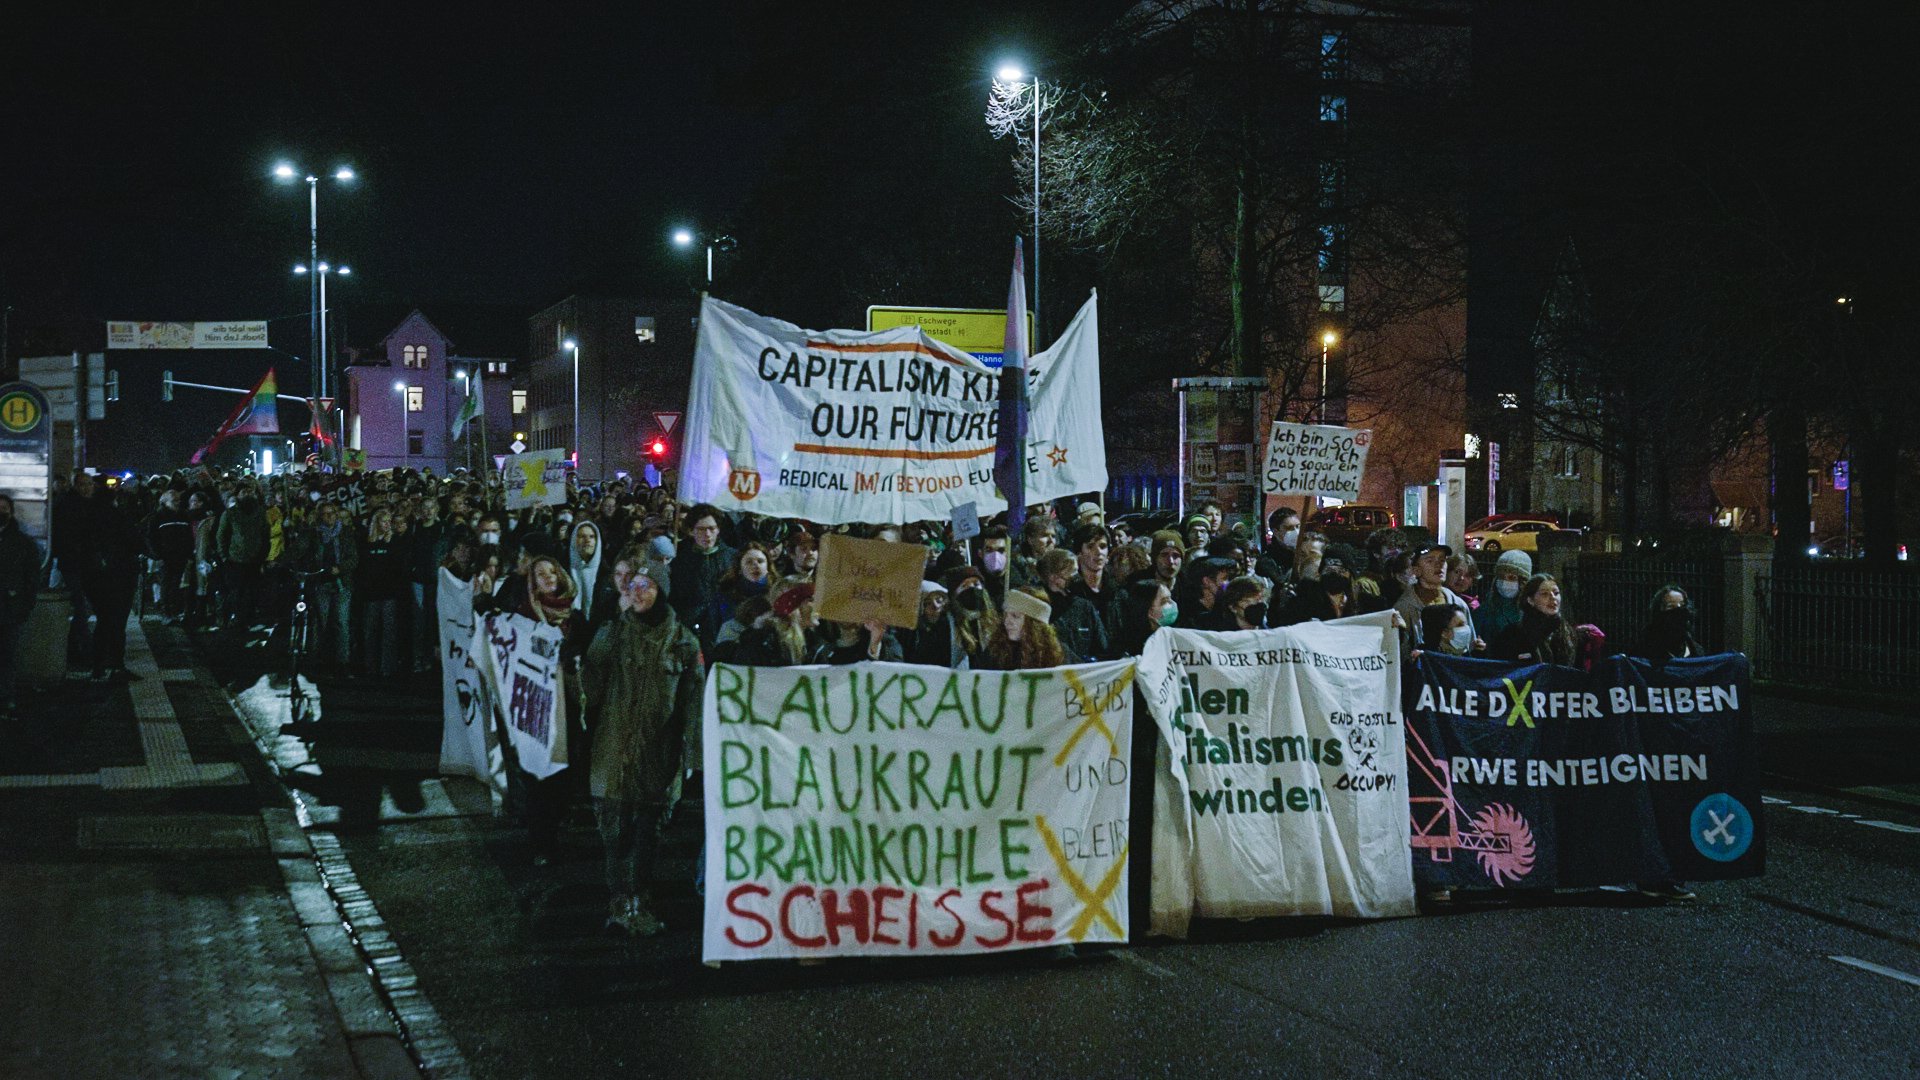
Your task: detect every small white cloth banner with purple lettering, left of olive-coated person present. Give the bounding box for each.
[470,613,566,780]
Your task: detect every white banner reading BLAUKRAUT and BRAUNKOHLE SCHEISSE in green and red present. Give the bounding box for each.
[701,661,1121,961]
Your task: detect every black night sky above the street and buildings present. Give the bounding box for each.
[0,0,1916,386]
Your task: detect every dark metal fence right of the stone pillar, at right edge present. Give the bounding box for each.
[1753,561,1920,692]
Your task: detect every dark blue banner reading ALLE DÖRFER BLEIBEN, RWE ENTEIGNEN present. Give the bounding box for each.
[1405,653,1766,888]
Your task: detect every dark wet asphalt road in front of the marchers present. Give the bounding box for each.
[210,638,1920,1080]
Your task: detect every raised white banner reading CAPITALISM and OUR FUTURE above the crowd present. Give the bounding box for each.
[680,298,1106,525]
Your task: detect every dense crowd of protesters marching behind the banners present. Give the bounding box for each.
[15,469,1701,934]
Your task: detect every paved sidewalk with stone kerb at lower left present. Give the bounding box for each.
[0,621,420,1078]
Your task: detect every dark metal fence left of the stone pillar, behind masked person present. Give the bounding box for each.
[1563,553,1726,651]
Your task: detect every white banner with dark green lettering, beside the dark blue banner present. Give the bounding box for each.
[1140,613,1415,936]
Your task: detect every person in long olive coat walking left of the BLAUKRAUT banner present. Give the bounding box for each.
[582,573,705,938]
